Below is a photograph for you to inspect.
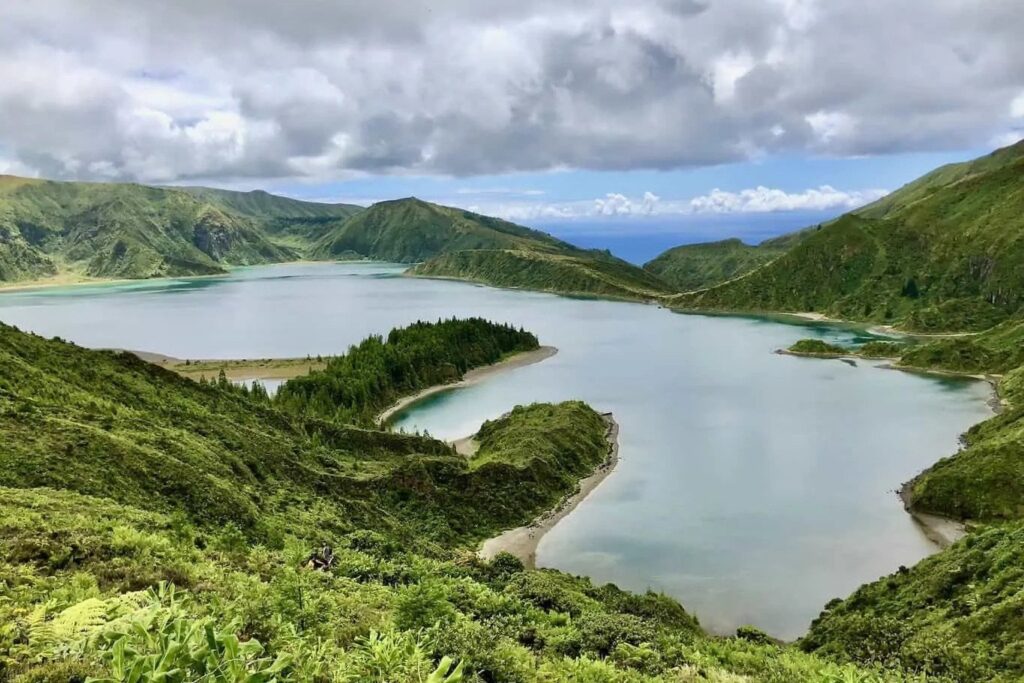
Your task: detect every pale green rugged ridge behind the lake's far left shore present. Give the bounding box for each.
[0,176,356,282]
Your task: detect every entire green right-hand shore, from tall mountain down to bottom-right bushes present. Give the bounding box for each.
[741,143,1024,682]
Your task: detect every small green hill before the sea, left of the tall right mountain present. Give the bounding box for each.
[643,239,785,292]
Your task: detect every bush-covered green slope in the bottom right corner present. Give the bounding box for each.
[801,523,1024,683]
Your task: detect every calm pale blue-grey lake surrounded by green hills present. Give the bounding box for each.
[0,264,989,638]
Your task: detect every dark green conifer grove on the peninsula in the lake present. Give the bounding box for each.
[274,317,540,426]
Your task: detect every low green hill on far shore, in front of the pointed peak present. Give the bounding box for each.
[409,249,673,300]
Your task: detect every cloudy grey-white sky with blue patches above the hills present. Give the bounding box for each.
[0,0,1024,255]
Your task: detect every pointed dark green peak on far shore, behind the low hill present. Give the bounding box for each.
[312,198,580,263]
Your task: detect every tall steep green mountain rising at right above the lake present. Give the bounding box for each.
[672,141,1024,330]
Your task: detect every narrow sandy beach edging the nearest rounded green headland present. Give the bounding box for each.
[477,413,618,568]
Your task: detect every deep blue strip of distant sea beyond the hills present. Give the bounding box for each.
[530,211,837,265]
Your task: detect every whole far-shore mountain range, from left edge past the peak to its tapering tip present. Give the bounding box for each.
[0,176,676,299]
